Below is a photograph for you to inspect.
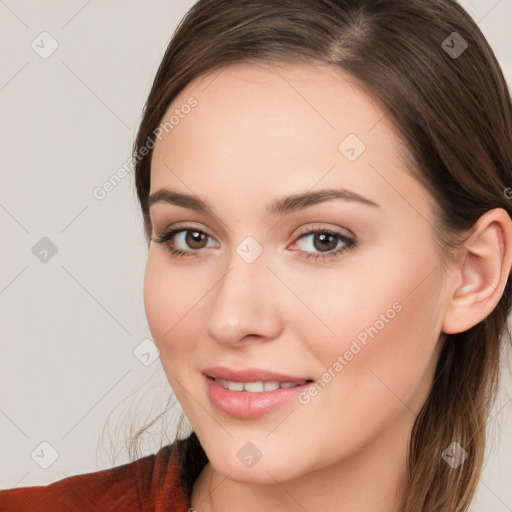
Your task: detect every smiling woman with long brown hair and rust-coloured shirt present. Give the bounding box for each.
[0,0,512,512]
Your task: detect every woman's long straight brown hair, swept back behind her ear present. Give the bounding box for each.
[129,0,512,512]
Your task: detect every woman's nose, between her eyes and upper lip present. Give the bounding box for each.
[206,248,283,348]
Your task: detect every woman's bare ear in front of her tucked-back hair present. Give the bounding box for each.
[443,208,512,334]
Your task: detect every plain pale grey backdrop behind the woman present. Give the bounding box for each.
[0,0,512,512]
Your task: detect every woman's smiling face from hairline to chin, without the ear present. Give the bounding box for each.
[144,64,447,483]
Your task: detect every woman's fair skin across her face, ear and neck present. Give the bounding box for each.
[144,64,512,512]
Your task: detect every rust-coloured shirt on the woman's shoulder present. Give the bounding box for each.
[0,445,190,512]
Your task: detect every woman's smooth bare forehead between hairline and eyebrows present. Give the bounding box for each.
[151,63,432,220]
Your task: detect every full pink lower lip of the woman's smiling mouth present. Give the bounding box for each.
[205,376,311,419]
